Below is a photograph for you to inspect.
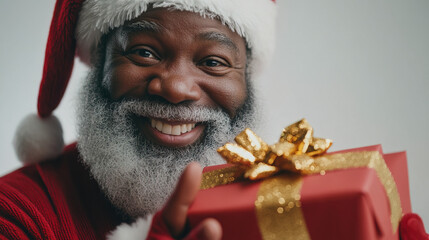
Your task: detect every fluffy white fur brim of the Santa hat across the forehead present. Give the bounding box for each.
[76,0,276,76]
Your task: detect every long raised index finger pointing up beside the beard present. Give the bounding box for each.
[163,162,202,237]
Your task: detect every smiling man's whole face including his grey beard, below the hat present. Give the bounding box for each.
[78,9,255,217]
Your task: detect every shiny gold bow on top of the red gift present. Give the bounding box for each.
[217,119,332,180]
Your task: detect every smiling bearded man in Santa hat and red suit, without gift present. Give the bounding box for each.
[0,0,275,239]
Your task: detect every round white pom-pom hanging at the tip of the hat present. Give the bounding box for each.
[13,114,64,164]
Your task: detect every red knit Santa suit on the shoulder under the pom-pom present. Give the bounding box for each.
[0,144,124,240]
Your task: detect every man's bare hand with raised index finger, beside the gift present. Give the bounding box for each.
[148,162,222,240]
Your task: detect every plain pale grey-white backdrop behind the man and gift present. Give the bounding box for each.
[0,0,429,227]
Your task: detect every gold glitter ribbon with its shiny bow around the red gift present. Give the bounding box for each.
[201,119,402,240]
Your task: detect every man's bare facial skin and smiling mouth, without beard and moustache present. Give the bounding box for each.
[103,8,247,147]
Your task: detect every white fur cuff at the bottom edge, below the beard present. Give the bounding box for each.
[107,215,153,240]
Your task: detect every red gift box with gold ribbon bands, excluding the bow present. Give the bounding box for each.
[188,122,411,240]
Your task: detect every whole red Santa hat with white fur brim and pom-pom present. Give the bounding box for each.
[14,0,276,163]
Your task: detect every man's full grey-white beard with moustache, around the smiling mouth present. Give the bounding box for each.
[78,62,256,217]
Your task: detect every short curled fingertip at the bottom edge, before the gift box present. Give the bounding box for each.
[184,218,222,240]
